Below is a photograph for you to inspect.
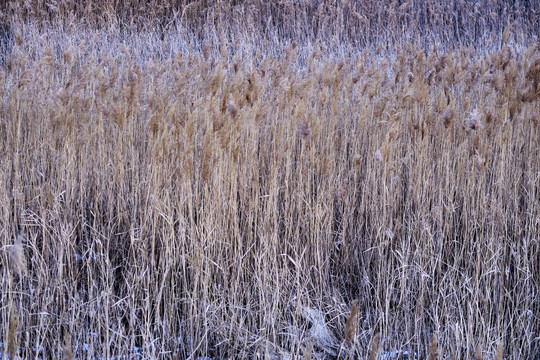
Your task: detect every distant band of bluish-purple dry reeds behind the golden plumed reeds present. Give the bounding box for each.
[0,0,540,46]
